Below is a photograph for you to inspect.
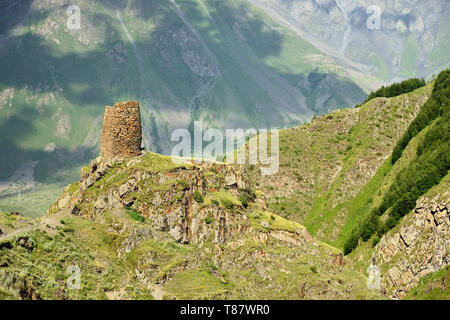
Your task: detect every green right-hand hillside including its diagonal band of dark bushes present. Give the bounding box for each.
[246,71,450,253]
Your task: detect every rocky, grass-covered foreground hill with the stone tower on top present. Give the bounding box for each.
[0,153,384,299]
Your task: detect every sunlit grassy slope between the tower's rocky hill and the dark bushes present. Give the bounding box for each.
[248,83,433,248]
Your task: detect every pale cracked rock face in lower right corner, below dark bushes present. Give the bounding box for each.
[372,199,450,298]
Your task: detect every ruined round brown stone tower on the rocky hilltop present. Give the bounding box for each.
[101,101,142,158]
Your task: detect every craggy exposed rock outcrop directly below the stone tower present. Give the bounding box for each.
[50,154,250,244]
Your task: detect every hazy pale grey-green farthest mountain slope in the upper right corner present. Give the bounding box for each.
[250,0,450,82]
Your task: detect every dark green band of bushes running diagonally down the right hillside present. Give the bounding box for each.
[344,70,450,254]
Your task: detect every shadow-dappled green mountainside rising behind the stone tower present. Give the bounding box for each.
[0,0,377,192]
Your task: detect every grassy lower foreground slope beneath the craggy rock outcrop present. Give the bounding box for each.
[0,205,380,299]
